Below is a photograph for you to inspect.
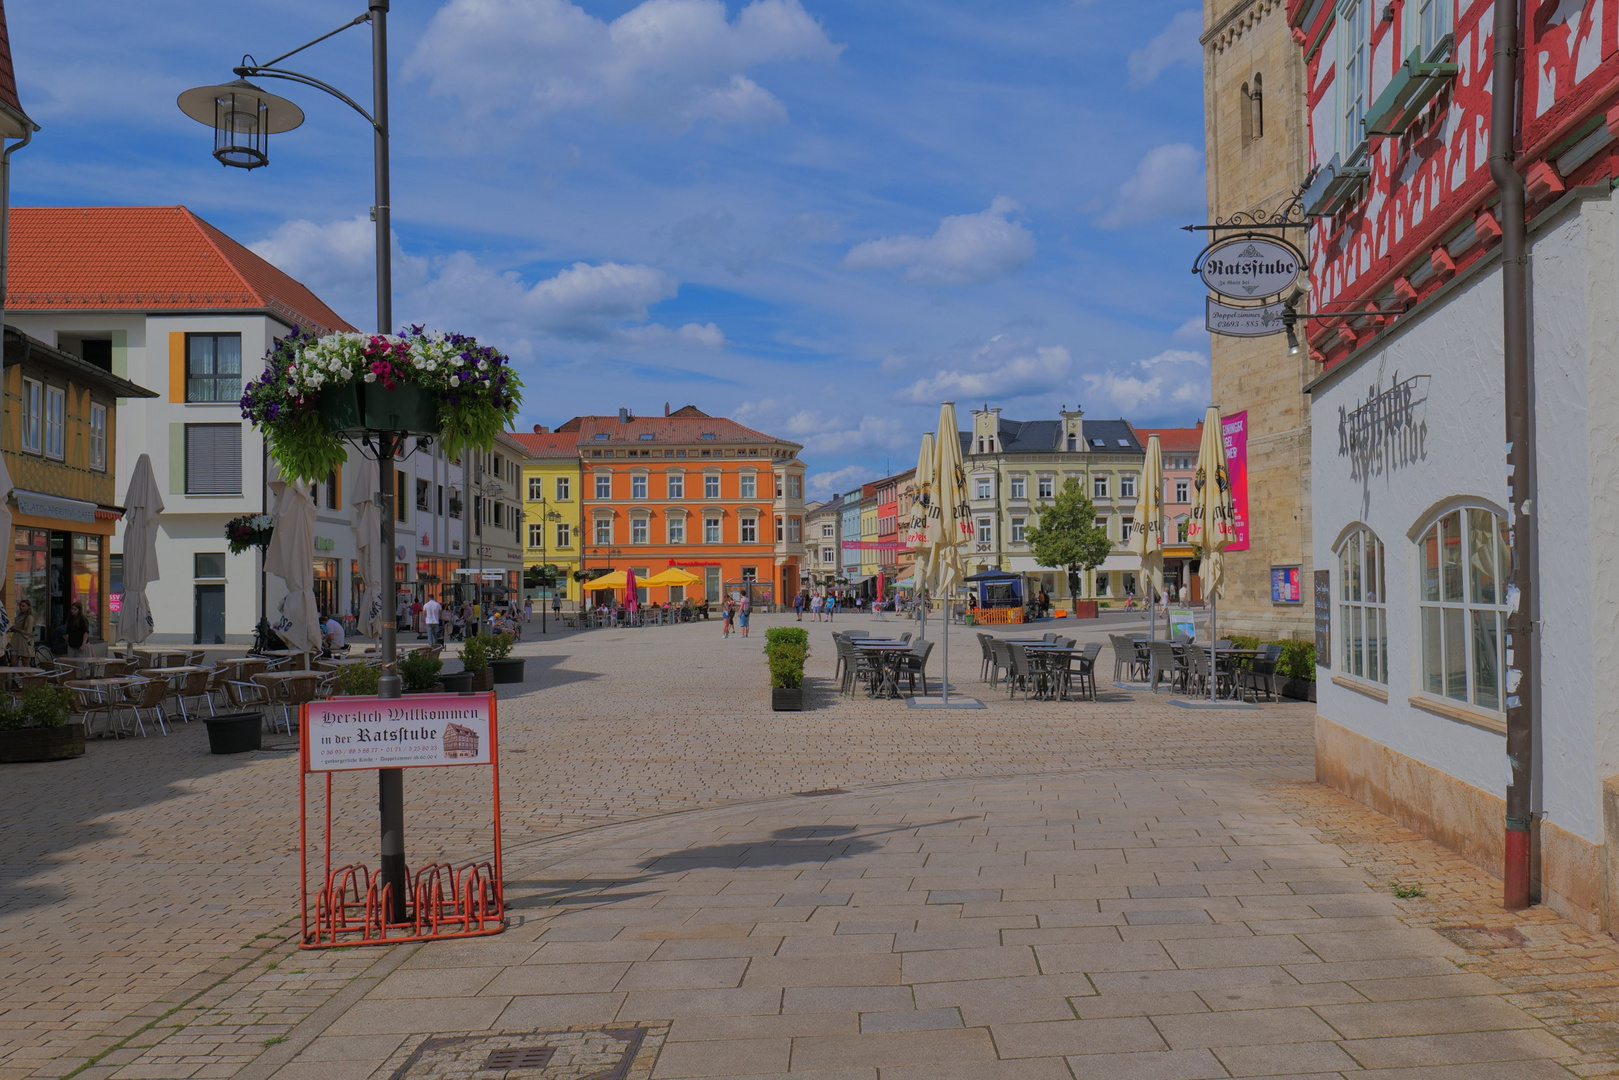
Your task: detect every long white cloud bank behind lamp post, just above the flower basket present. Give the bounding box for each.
[251,217,725,348]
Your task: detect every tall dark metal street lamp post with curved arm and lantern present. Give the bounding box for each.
[178,0,406,923]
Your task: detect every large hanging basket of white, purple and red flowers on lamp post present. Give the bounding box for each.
[241,325,523,481]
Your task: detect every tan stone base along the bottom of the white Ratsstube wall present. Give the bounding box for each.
[1316,716,1619,933]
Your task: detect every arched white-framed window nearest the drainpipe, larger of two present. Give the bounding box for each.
[1417,507,1512,712]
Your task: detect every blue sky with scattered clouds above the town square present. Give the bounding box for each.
[6,0,1208,495]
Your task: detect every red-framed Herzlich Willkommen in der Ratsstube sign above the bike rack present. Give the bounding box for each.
[303,693,495,772]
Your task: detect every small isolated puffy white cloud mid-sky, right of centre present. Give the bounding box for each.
[843,196,1035,285]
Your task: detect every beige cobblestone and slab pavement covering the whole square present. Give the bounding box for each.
[0,619,1619,1080]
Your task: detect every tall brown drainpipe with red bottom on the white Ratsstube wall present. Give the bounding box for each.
[1489,0,1540,912]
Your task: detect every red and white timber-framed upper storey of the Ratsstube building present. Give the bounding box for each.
[1287,0,1619,368]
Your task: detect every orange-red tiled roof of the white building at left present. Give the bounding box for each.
[6,206,355,334]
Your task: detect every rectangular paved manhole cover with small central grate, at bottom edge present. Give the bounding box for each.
[382,1023,669,1080]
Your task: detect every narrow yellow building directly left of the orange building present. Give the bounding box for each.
[512,426,584,606]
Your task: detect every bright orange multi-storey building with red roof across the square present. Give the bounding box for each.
[557,405,805,604]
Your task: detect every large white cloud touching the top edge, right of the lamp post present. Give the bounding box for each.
[410,0,842,128]
